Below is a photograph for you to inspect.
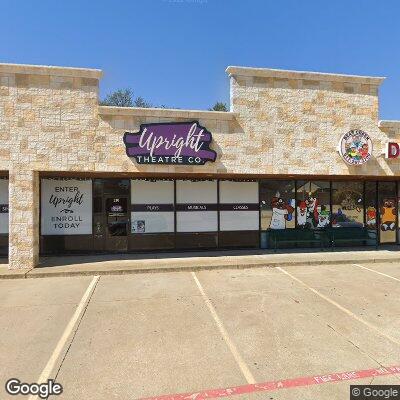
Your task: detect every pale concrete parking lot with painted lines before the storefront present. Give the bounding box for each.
[0,263,400,400]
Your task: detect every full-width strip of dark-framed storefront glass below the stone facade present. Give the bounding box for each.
[40,177,400,254]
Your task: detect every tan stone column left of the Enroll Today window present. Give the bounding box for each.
[8,168,40,269]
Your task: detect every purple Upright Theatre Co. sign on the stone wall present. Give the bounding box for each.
[124,121,217,165]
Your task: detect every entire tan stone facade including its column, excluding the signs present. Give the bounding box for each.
[0,64,400,268]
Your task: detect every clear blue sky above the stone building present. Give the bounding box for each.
[0,0,400,120]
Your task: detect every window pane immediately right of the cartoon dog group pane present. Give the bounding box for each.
[331,181,364,228]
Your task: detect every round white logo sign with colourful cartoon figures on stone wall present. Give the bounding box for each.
[339,129,372,165]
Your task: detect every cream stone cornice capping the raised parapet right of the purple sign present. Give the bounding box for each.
[225,66,386,86]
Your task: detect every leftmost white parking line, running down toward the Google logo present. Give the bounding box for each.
[28,275,100,400]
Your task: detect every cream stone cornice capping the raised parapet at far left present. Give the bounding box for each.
[0,63,103,79]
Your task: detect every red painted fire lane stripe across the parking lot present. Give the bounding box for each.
[140,365,400,400]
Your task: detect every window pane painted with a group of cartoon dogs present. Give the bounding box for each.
[296,181,331,229]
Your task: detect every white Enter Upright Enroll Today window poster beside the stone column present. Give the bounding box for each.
[40,179,92,235]
